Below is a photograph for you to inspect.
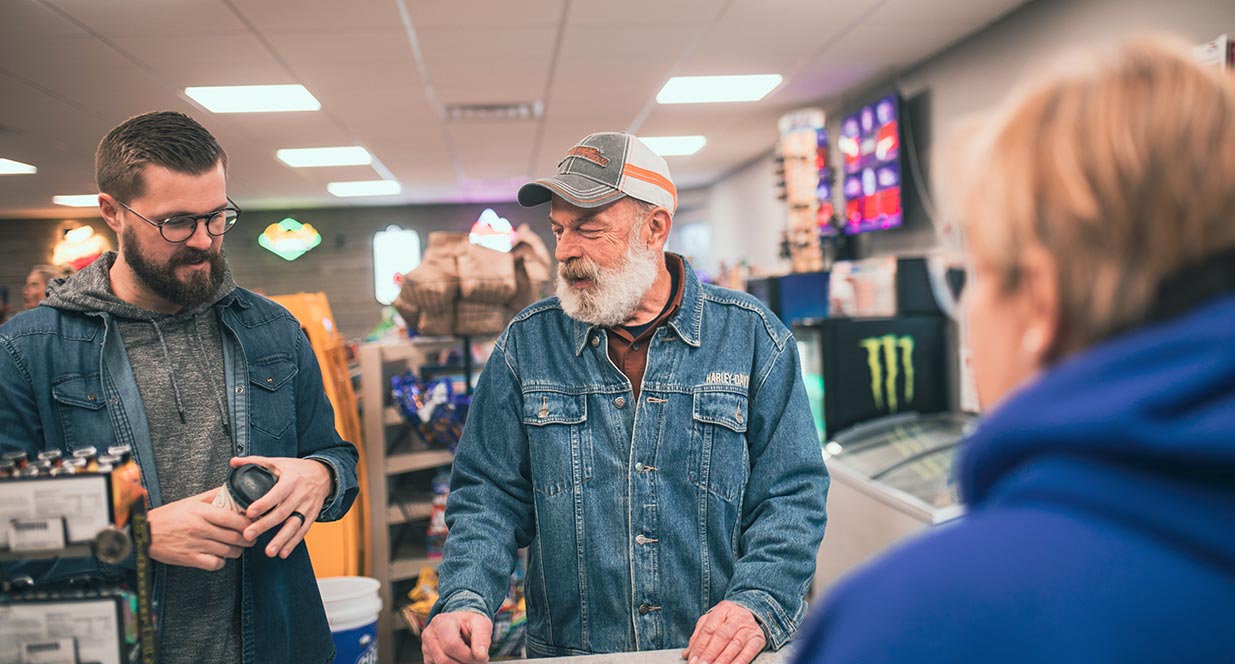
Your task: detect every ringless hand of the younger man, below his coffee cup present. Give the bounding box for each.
[148,489,252,571]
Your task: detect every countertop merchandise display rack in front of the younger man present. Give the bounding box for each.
[0,453,158,664]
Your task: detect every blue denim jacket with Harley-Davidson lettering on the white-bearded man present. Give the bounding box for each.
[435,255,829,657]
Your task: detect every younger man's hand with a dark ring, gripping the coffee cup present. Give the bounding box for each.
[231,457,333,558]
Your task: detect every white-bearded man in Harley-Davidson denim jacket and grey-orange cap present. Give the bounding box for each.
[422,133,827,664]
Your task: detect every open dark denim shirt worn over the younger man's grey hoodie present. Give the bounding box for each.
[0,289,358,664]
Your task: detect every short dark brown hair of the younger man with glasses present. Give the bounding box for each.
[94,111,227,202]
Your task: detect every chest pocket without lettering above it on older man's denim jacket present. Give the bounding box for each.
[524,391,592,496]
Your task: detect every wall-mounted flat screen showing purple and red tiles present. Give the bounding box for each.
[836,93,905,234]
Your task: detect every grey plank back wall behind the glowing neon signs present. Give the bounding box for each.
[0,204,552,337]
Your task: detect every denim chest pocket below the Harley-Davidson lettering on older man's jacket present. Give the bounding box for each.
[690,389,750,500]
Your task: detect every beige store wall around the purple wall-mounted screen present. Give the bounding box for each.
[710,0,1235,271]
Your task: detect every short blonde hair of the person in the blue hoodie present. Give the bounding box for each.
[945,37,1235,355]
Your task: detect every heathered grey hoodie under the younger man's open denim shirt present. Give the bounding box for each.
[42,252,241,664]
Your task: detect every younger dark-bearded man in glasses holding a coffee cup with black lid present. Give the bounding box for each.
[0,112,357,664]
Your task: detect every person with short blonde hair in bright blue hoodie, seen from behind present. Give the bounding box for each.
[798,39,1235,664]
